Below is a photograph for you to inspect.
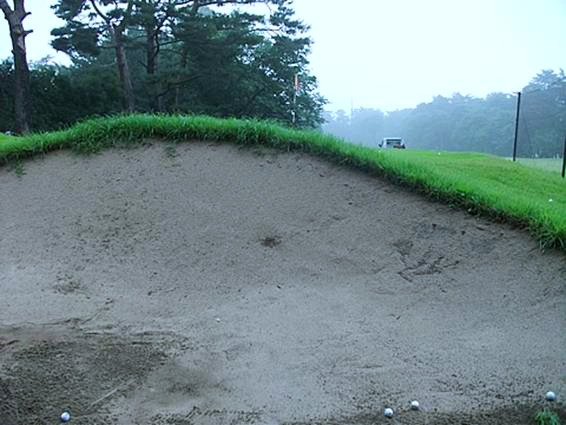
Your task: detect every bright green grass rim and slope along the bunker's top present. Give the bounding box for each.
[0,115,566,250]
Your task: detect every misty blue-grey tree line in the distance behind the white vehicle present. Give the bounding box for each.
[323,70,566,157]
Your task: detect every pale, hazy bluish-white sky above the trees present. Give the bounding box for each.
[0,0,566,111]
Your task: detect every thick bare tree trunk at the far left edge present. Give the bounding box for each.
[0,0,31,134]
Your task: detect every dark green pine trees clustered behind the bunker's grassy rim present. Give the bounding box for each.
[0,0,326,132]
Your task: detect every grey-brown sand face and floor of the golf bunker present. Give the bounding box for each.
[0,143,566,425]
